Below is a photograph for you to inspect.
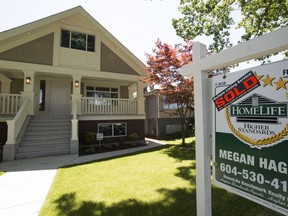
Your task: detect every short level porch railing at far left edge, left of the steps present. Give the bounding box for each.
[0,94,22,114]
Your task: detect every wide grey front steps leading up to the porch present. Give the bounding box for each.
[16,116,71,159]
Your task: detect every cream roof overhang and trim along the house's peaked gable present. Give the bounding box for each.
[0,6,146,75]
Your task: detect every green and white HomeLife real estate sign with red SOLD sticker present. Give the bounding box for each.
[212,61,288,215]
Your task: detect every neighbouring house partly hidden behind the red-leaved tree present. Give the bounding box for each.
[145,89,194,139]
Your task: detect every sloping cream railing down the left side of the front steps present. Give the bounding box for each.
[7,99,29,144]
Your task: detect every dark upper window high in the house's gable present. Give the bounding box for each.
[61,29,95,52]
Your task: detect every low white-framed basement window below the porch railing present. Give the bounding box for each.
[98,122,127,137]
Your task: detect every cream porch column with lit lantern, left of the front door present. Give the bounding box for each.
[21,70,35,115]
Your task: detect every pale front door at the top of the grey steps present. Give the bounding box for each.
[49,80,71,116]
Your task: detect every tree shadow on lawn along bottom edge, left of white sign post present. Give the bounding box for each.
[54,189,196,216]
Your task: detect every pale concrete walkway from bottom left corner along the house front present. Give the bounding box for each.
[0,139,162,216]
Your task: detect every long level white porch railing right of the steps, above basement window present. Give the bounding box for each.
[81,97,137,115]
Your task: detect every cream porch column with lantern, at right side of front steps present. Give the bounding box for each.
[70,75,82,154]
